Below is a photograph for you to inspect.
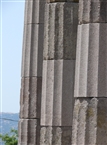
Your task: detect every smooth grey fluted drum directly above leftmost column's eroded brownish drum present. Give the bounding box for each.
[21,24,44,77]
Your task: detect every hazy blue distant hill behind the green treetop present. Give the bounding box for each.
[0,112,19,145]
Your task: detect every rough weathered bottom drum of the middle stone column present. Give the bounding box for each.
[40,127,72,145]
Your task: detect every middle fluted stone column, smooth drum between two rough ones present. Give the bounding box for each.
[40,2,78,145]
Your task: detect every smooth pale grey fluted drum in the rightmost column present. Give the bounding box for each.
[74,23,107,97]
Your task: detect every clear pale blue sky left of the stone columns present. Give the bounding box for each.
[0,0,24,113]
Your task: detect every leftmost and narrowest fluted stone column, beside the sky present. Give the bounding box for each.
[18,0,45,145]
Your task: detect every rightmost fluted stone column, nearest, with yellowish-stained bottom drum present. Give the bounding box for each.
[72,0,107,145]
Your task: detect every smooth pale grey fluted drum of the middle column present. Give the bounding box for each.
[41,60,75,126]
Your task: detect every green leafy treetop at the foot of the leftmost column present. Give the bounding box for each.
[0,129,18,145]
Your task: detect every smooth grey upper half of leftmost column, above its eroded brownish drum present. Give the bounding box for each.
[21,0,46,77]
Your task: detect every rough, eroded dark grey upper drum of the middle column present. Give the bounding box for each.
[44,2,78,60]
